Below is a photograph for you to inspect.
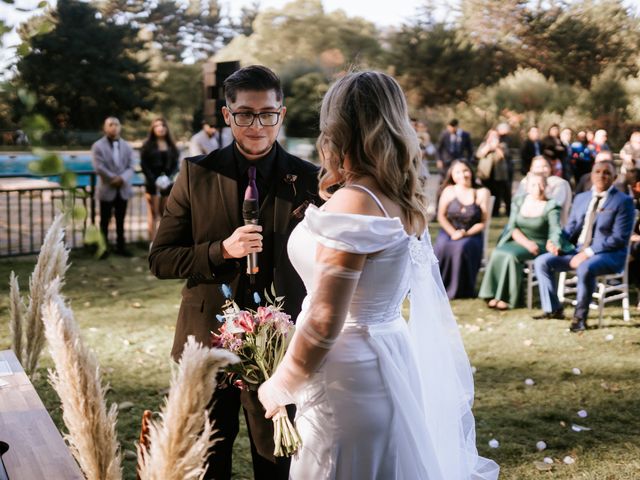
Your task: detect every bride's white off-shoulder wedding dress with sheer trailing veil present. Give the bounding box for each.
[288,187,499,480]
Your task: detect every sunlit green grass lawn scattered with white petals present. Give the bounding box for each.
[0,221,640,480]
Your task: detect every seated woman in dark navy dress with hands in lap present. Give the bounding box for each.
[433,160,489,298]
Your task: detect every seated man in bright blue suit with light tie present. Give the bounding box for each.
[534,161,635,332]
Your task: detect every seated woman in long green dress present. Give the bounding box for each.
[478,174,573,310]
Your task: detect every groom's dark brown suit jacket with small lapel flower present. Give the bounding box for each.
[149,143,319,360]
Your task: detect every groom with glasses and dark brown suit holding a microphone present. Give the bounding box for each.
[149,65,318,480]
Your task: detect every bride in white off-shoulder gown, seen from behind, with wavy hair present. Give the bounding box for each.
[259,72,499,480]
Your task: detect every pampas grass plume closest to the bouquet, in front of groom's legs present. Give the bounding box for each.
[138,336,238,480]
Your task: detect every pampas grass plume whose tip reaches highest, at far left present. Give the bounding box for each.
[23,215,69,375]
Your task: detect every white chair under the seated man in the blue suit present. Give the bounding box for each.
[558,243,631,327]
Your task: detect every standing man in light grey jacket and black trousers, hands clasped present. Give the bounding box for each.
[91,117,135,257]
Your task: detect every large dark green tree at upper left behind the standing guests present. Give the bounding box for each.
[17,0,152,129]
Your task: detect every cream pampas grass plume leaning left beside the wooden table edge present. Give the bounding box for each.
[42,278,122,480]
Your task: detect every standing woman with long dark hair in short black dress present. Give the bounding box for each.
[140,118,179,242]
